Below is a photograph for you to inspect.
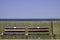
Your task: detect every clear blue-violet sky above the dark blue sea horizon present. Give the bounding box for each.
[0,0,60,19]
